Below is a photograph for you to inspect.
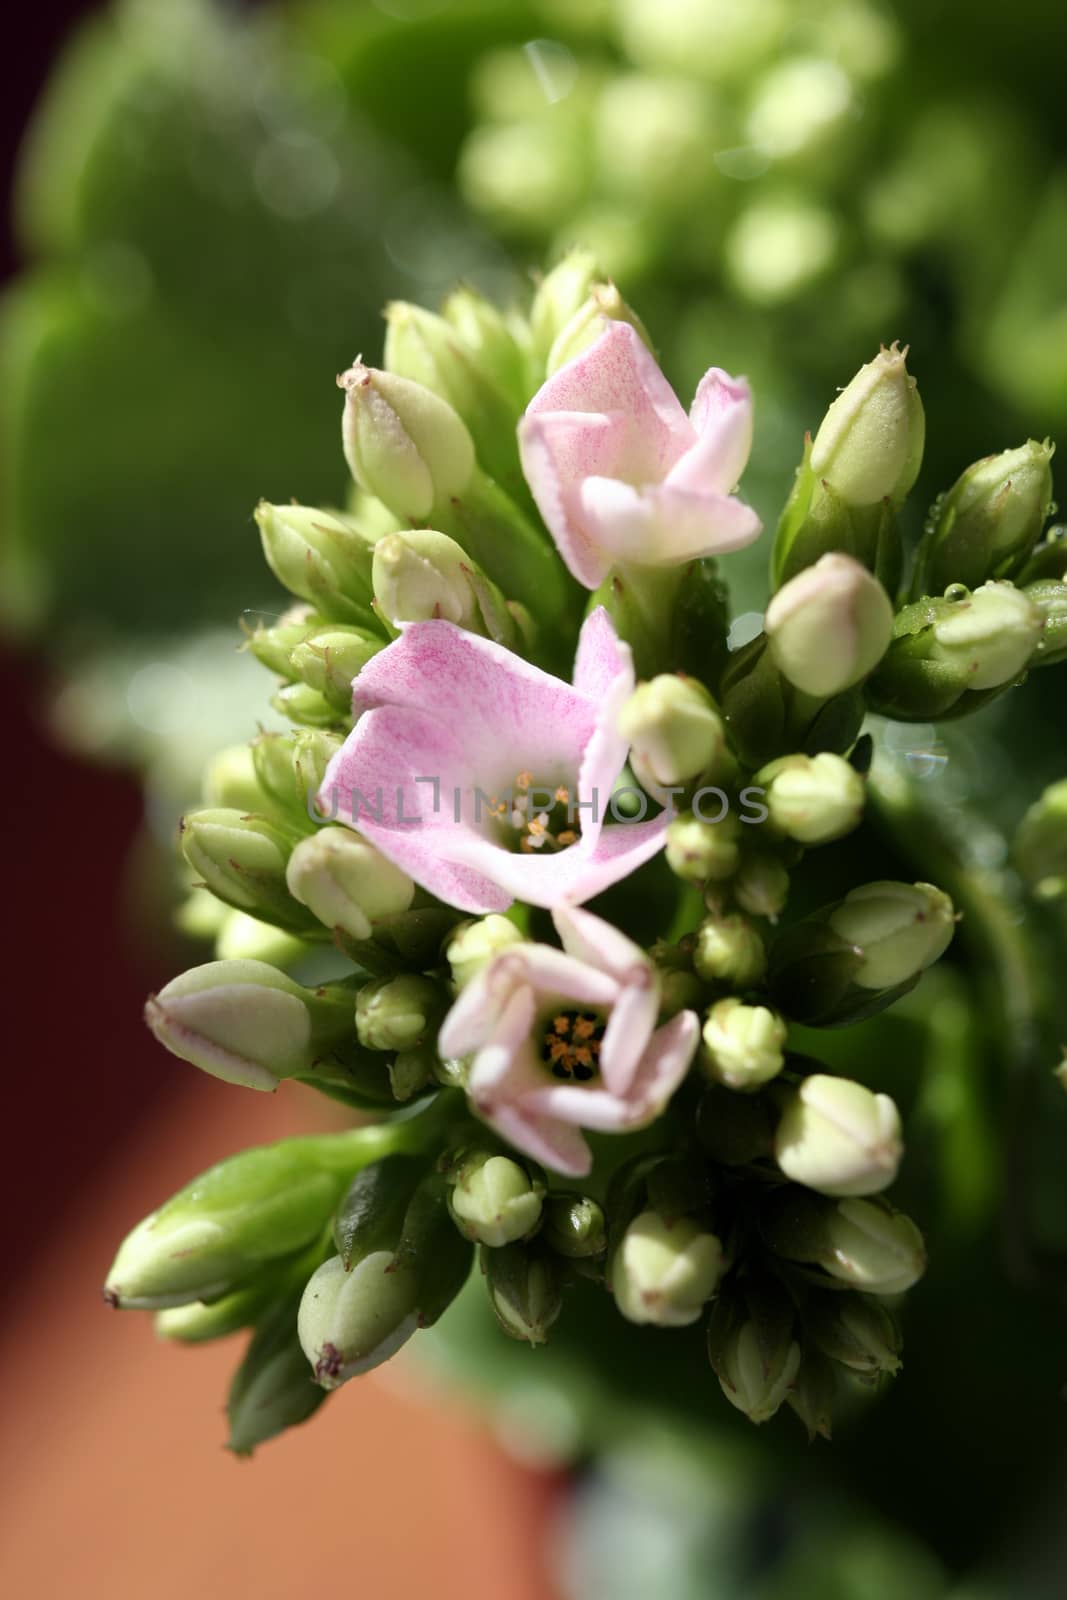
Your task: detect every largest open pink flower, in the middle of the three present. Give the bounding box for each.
[318,608,669,912]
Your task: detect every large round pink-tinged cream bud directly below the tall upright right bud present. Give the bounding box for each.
[763,554,893,699]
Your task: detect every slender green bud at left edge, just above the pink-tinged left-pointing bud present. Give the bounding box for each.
[181,806,310,933]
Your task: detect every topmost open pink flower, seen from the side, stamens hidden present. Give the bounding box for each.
[518,322,760,589]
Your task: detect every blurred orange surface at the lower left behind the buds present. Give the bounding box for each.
[0,1075,557,1600]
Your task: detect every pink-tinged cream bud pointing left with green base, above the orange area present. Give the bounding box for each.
[144,962,352,1090]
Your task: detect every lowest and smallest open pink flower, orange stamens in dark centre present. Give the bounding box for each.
[438,907,699,1178]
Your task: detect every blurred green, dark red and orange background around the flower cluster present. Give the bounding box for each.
[0,0,1067,1600]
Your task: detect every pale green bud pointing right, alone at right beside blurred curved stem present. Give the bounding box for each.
[829,882,955,989]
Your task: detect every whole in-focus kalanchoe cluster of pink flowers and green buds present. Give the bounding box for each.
[106,256,1067,1451]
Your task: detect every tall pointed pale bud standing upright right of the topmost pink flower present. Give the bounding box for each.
[811,346,926,506]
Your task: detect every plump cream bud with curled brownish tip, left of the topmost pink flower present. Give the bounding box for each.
[338,362,475,523]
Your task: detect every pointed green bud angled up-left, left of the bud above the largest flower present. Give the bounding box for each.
[256,501,374,627]
